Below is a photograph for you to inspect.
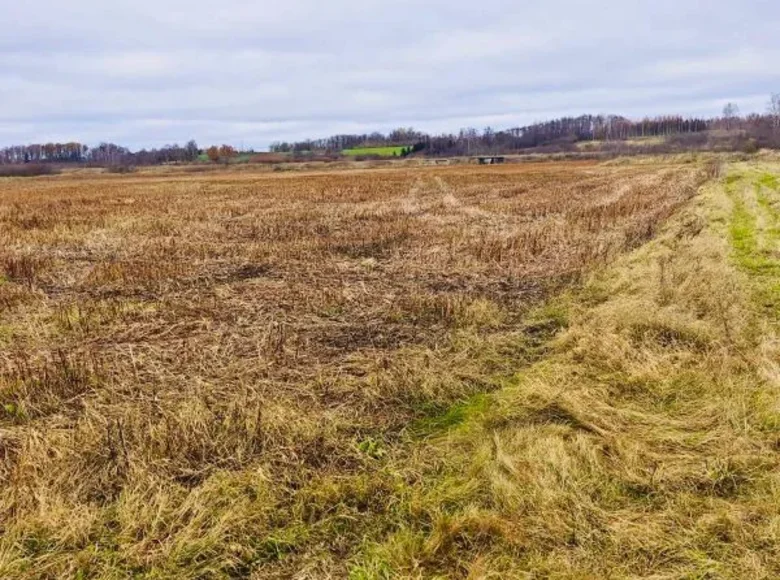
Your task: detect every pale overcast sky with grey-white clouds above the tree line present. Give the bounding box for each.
[0,0,780,148]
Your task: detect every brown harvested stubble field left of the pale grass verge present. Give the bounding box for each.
[0,163,708,578]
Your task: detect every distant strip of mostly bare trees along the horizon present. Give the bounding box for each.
[0,93,780,173]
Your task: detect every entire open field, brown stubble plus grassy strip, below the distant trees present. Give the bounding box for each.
[0,160,780,578]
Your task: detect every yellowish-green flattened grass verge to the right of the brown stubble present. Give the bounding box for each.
[352,161,780,578]
